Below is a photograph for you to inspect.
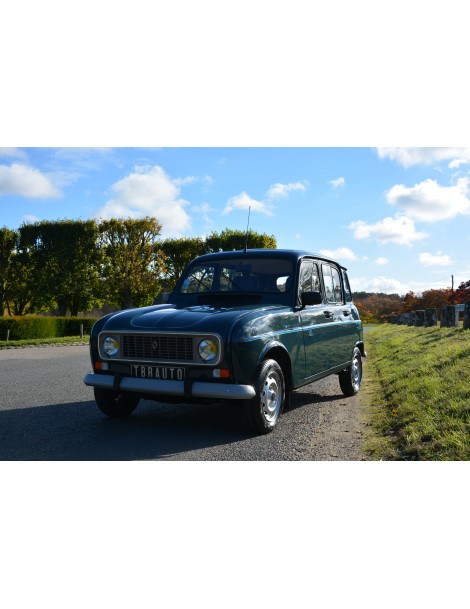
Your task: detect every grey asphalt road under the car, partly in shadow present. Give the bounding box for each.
[0,346,363,461]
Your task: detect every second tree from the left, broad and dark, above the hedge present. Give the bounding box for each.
[20,220,100,316]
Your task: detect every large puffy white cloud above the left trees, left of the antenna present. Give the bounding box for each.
[96,165,191,237]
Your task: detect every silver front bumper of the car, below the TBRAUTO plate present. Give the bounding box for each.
[83,372,256,400]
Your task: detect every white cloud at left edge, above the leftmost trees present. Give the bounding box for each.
[0,163,61,199]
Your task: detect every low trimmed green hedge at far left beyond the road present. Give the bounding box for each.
[0,315,96,340]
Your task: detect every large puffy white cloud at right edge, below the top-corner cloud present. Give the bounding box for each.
[386,178,470,222]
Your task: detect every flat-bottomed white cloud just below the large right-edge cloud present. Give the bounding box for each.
[348,216,428,245]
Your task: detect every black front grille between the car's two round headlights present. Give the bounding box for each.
[121,334,194,361]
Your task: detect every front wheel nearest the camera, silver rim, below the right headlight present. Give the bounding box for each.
[245,359,285,434]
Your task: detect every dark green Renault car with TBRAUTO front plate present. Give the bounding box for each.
[84,250,365,433]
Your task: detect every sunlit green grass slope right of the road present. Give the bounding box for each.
[365,324,470,461]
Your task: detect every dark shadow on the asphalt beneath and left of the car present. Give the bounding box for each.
[0,400,253,461]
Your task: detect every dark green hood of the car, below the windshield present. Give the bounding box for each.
[102,305,285,334]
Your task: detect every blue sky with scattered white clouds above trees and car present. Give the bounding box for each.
[0,147,470,294]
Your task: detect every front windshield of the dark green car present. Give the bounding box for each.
[179,257,293,296]
